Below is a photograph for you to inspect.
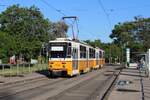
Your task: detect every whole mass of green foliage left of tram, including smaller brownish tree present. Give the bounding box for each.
[0,5,68,61]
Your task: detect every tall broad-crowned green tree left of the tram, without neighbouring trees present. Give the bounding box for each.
[0,5,50,60]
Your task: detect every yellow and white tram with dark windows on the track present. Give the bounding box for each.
[48,38,105,76]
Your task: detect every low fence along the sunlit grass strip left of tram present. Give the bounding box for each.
[0,63,48,76]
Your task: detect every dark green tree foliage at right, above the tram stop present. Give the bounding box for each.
[110,17,150,52]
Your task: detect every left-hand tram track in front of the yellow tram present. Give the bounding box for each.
[0,70,97,99]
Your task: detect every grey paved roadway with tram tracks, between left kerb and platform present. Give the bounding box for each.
[0,66,119,100]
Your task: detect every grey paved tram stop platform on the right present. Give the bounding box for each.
[108,67,150,100]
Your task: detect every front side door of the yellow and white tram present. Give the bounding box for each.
[72,48,78,70]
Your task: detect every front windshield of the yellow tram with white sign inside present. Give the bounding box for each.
[49,43,68,58]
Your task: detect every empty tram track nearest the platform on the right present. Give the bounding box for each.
[47,66,120,100]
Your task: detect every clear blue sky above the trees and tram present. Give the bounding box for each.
[0,0,150,43]
